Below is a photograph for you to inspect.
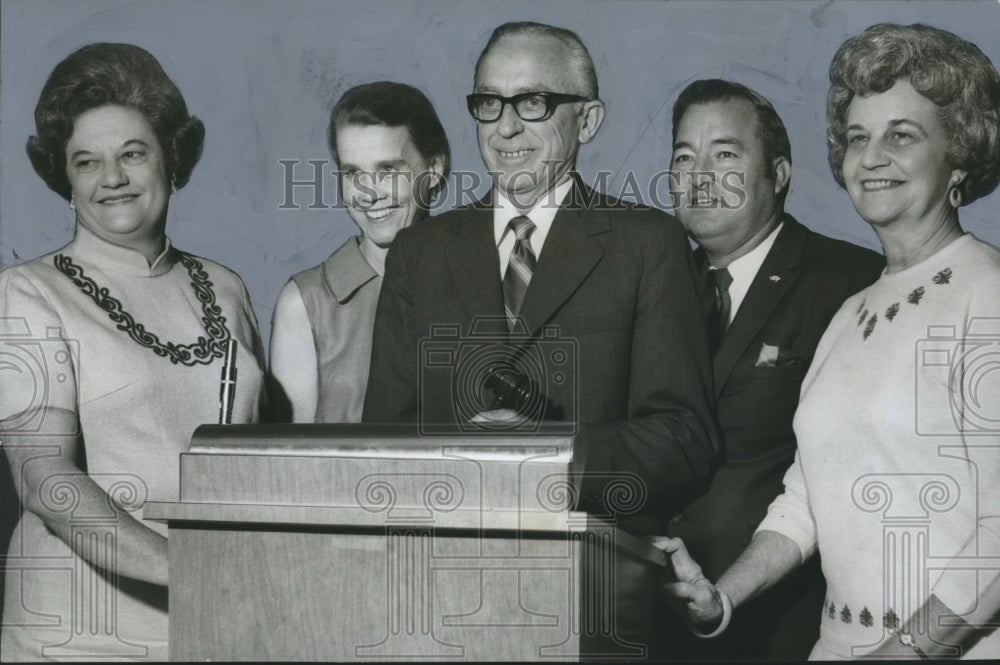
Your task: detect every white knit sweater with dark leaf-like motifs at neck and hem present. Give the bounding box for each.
[758,235,1000,658]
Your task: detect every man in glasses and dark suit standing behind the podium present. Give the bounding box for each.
[364,23,717,533]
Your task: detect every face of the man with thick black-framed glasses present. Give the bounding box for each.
[475,35,604,210]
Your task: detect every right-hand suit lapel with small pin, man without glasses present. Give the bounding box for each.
[713,215,806,395]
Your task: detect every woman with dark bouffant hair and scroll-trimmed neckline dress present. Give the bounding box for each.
[0,44,263,661]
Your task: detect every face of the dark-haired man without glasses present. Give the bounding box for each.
[671,99,791,268]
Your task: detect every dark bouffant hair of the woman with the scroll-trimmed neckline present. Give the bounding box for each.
[27,44,205,200]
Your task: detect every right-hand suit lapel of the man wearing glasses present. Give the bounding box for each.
[516,181,611,334]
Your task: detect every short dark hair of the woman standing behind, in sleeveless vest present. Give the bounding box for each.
[327,81,451,195]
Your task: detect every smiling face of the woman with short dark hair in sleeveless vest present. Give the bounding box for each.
[337,124,443,248]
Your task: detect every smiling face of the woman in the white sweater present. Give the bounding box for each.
[844,79,964,230]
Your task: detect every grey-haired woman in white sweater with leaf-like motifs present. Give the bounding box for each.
[660,24,1000,659]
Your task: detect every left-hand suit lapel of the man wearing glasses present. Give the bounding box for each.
[445,202,507,333]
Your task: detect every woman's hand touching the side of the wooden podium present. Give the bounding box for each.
[652,537,723,632]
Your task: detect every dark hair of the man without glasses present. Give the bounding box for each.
[671,79,792,200]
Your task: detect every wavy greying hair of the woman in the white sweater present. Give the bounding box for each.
[826,23,1000,204]
